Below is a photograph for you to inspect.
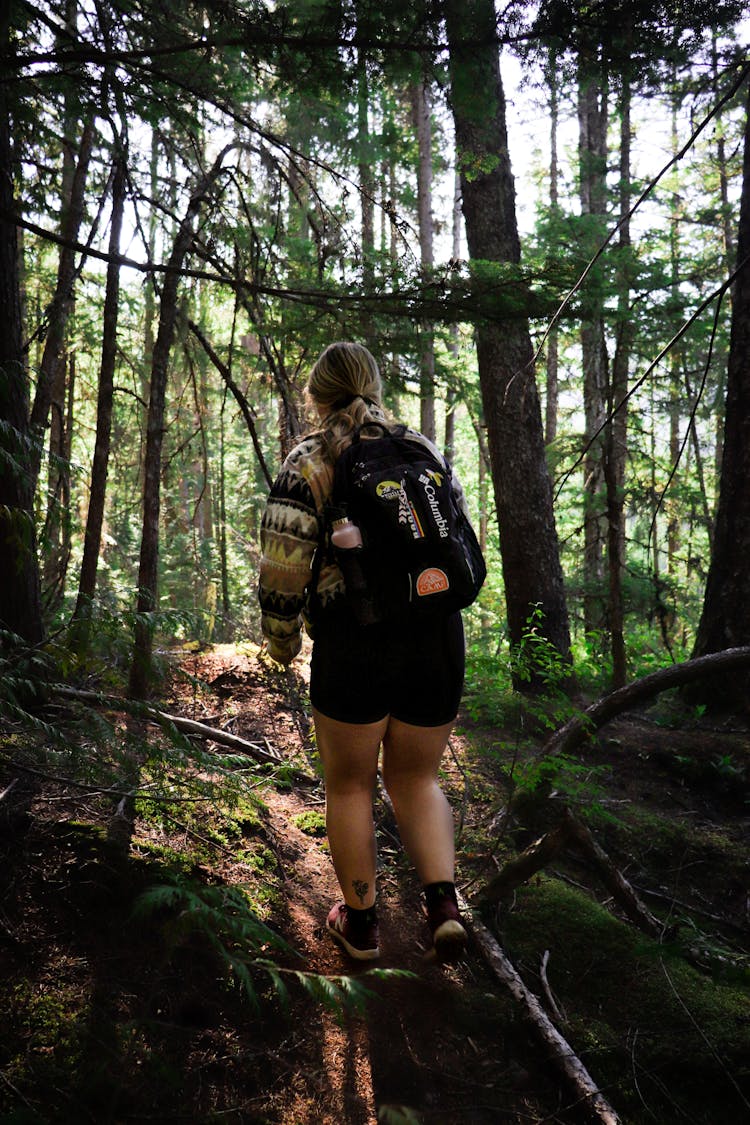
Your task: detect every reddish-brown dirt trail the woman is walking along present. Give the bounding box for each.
[178,647,553,1125]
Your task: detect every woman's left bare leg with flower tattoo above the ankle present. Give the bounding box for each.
[313,709,388,910]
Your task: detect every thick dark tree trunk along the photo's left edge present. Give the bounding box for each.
[0,6,43,645]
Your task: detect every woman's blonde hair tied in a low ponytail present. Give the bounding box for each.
[307,341,386,461]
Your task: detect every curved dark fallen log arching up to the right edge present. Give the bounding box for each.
[541,646,750,756]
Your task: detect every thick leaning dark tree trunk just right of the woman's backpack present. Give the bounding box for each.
[445,0,570,686]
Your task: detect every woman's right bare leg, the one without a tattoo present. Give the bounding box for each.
[383,718,455,884]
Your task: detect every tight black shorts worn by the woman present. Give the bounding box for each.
[310,609,466,727]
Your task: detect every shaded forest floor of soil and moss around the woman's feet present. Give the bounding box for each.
[0,646,750,1125]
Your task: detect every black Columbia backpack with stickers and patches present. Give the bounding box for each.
[326,423,487,624]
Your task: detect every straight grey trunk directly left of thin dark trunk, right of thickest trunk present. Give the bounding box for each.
[578,47,608,633]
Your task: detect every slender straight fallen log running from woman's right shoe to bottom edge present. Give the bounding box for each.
[458,894,620,1125]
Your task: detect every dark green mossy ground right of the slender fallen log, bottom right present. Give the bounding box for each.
[501,876,750,1125]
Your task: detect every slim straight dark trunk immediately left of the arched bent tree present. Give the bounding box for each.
[73,153,126,651]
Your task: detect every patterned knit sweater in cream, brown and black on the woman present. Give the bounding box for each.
[257,430,468,664]
